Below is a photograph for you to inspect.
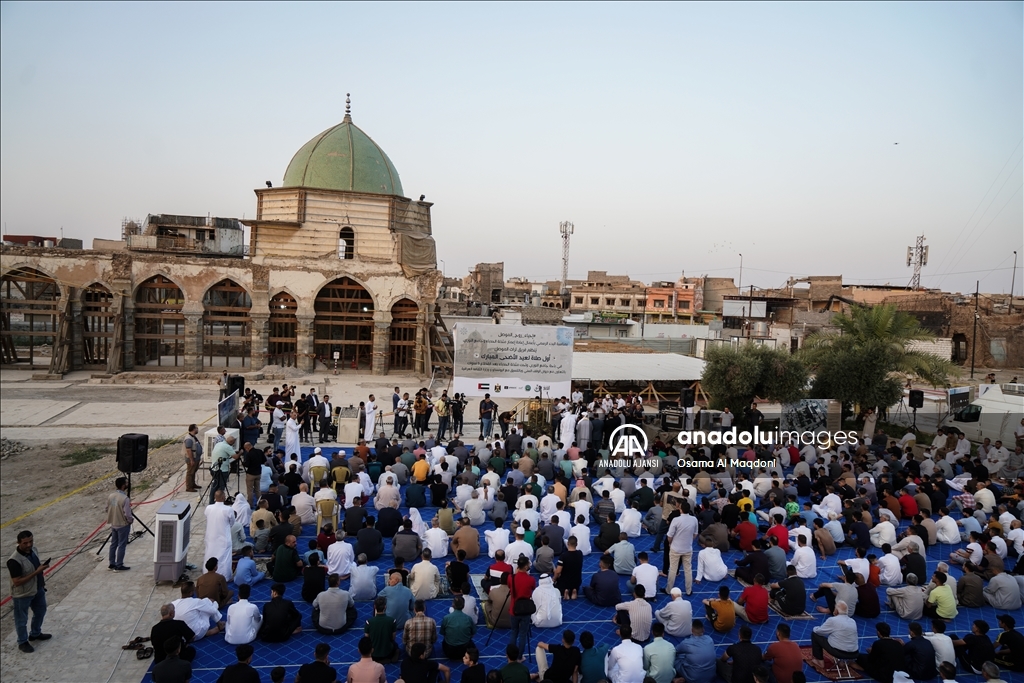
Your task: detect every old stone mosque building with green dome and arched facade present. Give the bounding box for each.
[0,103,450,375]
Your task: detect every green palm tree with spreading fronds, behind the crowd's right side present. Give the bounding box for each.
[800,304,956,408]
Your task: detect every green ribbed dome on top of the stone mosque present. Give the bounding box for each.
[282,113,402,196]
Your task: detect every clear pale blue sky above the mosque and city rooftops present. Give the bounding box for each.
[0,2,1024,294]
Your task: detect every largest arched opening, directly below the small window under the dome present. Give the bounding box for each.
[313,278,374,369]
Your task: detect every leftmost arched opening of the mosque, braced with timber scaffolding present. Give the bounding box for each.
[0,268,60,368]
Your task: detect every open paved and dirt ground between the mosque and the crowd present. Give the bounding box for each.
[0,370,436,683]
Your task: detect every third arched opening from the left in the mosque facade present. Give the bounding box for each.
[135,275,185,368]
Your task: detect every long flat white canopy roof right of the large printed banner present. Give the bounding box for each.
[572,351,705,382]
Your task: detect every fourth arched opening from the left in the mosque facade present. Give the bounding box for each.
[203,280,253,368]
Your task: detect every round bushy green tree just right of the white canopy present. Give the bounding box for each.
[700,344,807,415]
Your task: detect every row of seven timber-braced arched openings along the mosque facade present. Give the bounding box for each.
[0,268,419,371]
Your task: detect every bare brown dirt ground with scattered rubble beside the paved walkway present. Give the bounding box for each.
[0,438,183,638]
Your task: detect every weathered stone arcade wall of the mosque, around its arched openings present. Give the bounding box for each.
[0,246,440,375]
